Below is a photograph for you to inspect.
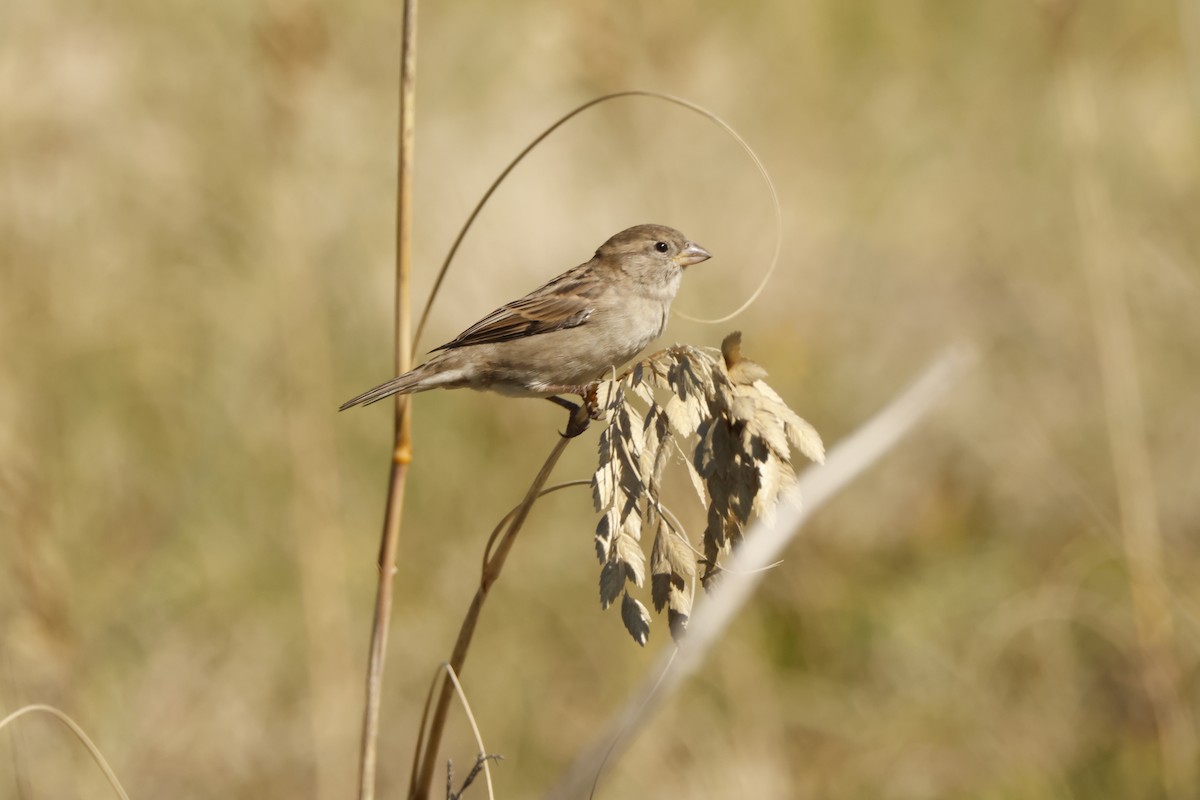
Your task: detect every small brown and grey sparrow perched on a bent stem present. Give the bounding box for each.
[342,225,709,410]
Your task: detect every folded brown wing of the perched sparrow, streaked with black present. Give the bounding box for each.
[434,264,605,350]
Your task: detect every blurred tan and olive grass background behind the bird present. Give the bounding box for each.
[0,0,1200,800]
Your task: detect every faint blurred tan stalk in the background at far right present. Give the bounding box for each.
[1057,58,1198,800]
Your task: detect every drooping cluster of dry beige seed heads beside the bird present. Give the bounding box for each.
[592,332,824,644]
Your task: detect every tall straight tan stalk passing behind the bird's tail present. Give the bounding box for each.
[359,0,416,800]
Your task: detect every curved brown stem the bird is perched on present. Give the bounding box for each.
[408,408,587,800]
